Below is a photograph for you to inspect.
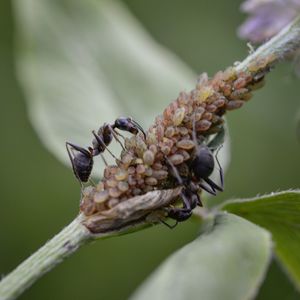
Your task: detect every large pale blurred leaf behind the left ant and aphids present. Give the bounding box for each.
[14,0,196,163]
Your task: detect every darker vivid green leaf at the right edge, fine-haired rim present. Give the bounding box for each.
[222,191,300,290]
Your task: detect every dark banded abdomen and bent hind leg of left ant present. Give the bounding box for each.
[66,142,94,185]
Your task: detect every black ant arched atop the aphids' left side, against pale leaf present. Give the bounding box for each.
[66,117,146,185]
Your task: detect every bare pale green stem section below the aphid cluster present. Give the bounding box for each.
[0,215,91,300]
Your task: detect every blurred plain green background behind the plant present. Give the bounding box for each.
[0,0,300,300]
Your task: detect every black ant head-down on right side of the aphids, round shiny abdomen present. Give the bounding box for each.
[163,125,224,228]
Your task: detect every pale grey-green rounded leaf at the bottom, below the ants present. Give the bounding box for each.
[131,214,272,300]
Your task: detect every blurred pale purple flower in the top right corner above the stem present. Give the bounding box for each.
[238,0,300,44]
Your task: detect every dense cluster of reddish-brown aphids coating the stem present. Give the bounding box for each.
[80,61,268,216]
